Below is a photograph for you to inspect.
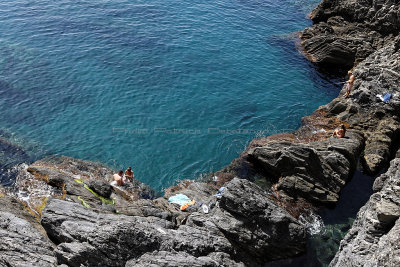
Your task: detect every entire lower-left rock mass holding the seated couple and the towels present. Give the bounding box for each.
[0,157,306,266]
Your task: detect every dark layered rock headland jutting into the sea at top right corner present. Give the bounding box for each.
[301,0,400,67]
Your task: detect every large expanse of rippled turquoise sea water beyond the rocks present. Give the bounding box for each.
[0,0,338,190]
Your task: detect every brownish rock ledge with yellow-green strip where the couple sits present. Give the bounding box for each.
[9,156,155,216]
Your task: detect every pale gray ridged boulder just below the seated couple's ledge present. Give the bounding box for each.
[41,199,172,266]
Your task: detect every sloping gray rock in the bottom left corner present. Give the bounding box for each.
[0,190,57,266]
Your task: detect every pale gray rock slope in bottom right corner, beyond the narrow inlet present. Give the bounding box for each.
[330,158,400,266]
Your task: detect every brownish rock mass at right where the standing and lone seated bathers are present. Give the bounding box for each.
[225,34,400,209]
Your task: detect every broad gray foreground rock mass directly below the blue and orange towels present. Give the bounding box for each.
[37,178,306,266]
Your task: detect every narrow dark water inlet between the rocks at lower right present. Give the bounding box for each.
[264,170,376,267]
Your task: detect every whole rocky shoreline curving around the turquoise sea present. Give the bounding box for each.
[0,0,400,266]
